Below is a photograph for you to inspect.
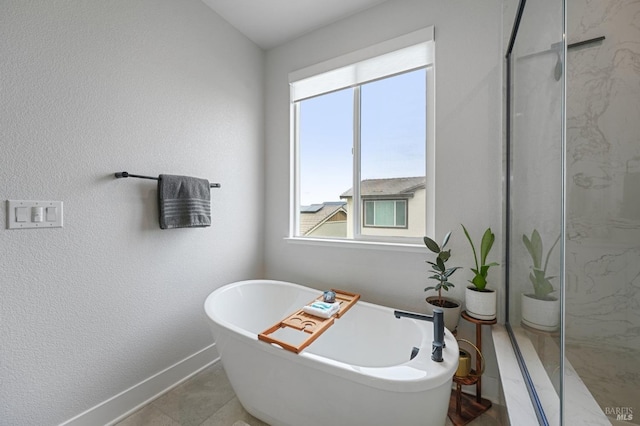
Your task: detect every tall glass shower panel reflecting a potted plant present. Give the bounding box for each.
[507,0,565,424]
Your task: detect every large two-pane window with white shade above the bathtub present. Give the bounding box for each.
[290,28,434,242]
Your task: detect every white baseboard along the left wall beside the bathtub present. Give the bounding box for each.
[60,343,220,426]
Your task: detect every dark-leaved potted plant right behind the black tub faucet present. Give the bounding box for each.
[424,232,462,331]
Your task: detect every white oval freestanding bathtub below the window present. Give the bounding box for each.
[205,280,458,426]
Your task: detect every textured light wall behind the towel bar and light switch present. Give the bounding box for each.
[0,0,264,425]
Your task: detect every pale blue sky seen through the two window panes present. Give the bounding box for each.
[299,70,426,205]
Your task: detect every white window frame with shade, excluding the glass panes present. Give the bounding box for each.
[289,26,436,245]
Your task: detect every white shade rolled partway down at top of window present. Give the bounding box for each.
[289,27,435,102]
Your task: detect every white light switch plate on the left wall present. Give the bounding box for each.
[7,200,62,229]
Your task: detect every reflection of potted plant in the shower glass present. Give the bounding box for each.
[522,229,560,331]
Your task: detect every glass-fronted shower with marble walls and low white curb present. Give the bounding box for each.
[505,0,640,425]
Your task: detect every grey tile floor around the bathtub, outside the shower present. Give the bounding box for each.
[115,362,500,426]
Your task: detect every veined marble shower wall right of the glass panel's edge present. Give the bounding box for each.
[565,0,640,350]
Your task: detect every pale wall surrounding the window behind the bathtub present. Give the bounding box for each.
[265,0,503,400]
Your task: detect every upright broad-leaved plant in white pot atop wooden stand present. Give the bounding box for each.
[462,225,498,320]
